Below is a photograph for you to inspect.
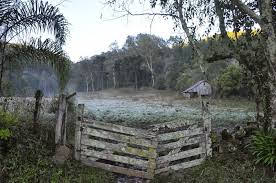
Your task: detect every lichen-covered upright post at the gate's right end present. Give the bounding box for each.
[202,101,212,157]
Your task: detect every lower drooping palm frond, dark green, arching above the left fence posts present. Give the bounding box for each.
[6,38,70,90]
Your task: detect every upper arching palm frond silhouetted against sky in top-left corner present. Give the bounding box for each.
[0,0,68,45]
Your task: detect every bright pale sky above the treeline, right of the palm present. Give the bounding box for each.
[45,0,179,62]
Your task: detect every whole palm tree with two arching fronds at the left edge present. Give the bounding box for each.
[0,0,69,96]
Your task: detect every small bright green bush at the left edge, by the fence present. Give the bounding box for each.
[0,110,17,140]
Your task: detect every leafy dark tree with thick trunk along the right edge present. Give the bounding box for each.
[211,0,276,130]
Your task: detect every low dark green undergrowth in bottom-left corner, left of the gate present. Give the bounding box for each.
[0,122,114,183]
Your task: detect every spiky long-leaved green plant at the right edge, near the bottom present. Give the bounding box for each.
[251,130,276,168]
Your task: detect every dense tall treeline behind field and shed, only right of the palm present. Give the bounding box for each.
[70,34,253,96]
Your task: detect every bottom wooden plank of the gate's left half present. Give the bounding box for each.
[81,157,153,179]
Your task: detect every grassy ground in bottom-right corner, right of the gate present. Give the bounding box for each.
[152,151,276,183]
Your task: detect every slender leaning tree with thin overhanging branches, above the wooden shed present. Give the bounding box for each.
[106,0,214,78]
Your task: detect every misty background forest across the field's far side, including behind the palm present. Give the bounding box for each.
[1,33,254,98]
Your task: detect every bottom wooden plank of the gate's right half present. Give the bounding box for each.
[155,158,204,174]
